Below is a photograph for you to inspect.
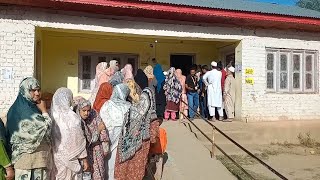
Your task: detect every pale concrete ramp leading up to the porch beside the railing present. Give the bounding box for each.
[161,121,236,180]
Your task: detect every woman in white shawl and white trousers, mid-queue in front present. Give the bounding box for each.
[100,84,131,180]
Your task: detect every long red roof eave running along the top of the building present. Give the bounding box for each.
[0,0,320,32]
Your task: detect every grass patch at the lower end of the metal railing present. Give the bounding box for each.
[216,155,273,180]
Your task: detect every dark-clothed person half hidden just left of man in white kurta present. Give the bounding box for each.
[199,65,209,118]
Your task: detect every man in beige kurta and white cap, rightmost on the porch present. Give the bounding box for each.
[223,66,236,122]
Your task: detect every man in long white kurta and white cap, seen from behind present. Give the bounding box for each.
[203,61,223,120]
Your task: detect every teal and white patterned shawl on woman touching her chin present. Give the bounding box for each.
[7,77,51,164]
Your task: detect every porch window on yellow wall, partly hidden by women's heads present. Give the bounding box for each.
[79,53,138,93]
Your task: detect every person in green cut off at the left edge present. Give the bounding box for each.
[0,119,14,180]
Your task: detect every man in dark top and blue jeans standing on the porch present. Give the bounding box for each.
[186,67,199,120]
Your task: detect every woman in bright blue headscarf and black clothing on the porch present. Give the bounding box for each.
[153,64,166,118]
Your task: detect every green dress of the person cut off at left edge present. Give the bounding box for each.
[0,119,11,180]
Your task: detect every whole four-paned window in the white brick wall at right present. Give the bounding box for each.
[266,49,317,93]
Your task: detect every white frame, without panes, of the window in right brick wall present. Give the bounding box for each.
[265,48,319,94]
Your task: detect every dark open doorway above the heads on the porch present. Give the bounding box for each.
[170,54,194,76]
